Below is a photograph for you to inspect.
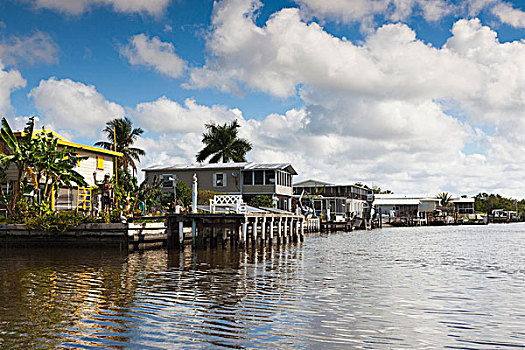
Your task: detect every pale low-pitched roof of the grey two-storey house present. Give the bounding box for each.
[142,162,297,175]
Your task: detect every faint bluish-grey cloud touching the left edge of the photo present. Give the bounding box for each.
[0,31,58,64]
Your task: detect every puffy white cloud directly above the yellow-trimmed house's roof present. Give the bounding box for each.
[29,77,124,136]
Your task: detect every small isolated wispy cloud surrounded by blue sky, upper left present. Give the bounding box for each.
[120,34,186,78]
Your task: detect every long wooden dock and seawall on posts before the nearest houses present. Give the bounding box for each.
[0,212,321,251]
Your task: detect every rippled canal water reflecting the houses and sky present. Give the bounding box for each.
[0,224,525,349]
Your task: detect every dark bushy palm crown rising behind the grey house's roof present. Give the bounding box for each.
[197,120,252,163]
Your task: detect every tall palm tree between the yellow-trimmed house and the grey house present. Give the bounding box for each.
[95,117,146,176]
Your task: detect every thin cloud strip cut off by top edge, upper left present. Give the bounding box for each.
[26,0,171,16]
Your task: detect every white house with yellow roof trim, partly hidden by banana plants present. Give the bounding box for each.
[0,130,122,210]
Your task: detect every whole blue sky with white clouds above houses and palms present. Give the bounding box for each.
[0,0,525,198]
